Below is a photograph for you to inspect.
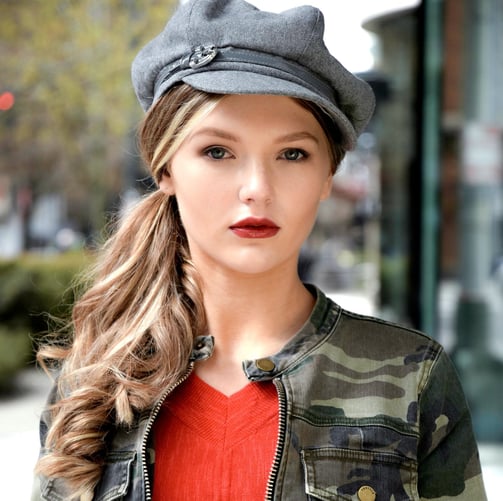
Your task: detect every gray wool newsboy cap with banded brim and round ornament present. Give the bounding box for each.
[132,0,375,149]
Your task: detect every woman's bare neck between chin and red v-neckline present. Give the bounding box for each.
[196,264,314,394]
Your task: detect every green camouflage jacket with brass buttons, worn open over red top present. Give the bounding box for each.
[33,291,486,501]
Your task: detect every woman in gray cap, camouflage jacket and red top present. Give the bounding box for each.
[35,0,485,501]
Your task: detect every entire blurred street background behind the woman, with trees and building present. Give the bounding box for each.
[0,0,503,501]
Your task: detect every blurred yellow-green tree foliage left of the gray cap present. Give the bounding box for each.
[0,0,177,234]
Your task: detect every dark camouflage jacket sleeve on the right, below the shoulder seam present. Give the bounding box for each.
[418,350,487,501]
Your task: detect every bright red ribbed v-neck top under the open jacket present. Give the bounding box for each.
[153,374,278,501]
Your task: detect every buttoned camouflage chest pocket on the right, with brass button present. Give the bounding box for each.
[300,448,419,501]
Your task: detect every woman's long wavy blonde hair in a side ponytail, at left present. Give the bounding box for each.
[36,86,221,498]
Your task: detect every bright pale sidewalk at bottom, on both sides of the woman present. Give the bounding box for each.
[0,369,503,501]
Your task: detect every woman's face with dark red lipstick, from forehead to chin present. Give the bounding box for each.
[160,95,332,274]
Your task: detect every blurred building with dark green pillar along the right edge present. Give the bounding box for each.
[365,0,503,441]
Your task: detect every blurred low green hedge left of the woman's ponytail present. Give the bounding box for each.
[0,251,92,385]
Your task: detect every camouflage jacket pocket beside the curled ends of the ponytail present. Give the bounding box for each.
[93,451,136,501]
